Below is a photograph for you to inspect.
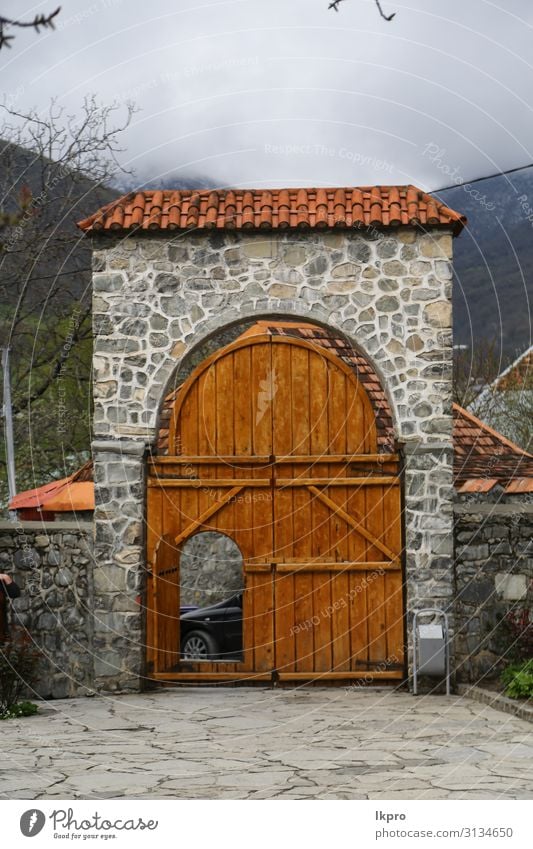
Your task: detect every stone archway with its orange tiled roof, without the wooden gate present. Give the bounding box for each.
[85,186,464,691]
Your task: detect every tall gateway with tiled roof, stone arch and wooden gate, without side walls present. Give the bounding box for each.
[76,186,464,690]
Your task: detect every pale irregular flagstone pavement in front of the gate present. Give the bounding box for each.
[0,687,533,799]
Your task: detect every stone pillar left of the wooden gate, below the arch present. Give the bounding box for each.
[92,439,145,692]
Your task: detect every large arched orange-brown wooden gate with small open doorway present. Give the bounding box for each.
[147,335,404,680]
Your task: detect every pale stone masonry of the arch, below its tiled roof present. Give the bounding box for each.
[93,227,453,690]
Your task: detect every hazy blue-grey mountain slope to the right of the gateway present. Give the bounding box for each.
[433,169,533,357]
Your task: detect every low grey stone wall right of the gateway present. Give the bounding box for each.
[455,493,533,681]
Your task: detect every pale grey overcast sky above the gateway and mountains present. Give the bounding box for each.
[0,0,533,189]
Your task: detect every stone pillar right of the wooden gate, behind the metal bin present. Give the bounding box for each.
[404,440,454,678]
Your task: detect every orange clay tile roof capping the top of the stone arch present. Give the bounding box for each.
[78,185,466,235]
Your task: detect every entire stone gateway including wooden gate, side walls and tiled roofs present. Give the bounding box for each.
[0,186,533,696]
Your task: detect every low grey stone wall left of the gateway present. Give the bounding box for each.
[0,522,94,698]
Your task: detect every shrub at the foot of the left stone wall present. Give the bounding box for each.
[0,630,39,718]
